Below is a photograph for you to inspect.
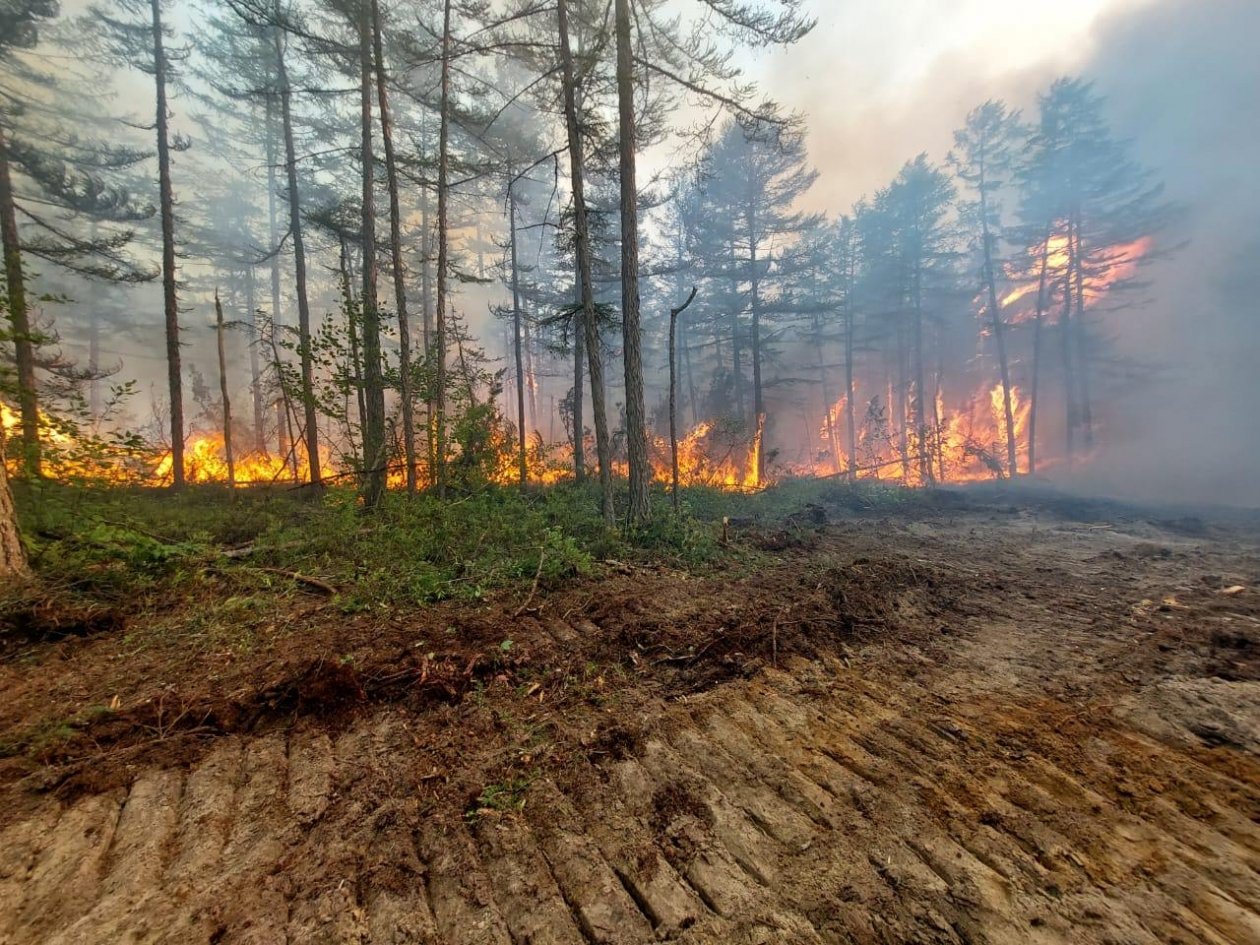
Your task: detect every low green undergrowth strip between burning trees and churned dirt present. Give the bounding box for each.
[0,480,919,651]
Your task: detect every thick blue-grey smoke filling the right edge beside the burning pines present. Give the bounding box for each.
[1063,0,1260,507]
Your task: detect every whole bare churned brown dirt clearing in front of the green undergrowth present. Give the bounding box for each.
[0,495,1260,945]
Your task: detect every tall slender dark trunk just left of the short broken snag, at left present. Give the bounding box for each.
[150,0,185,489]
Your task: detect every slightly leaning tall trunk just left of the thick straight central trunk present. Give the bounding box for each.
[556,0,614,525]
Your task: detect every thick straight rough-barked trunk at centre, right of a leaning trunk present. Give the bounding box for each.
[616,0,651,525]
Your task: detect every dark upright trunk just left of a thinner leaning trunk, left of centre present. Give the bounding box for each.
[359,0,386,509]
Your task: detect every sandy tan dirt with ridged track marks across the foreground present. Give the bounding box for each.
[0,663,1260,945]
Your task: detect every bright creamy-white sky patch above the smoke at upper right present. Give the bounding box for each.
[750,0,1148,212]
